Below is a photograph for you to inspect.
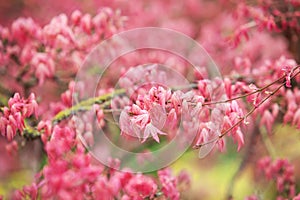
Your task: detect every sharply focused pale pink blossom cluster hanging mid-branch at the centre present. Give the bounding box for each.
[120,73,250,151]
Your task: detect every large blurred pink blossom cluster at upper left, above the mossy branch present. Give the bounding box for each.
[0,8,125,86]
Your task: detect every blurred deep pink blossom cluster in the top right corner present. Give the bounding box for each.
[229,0,300,47]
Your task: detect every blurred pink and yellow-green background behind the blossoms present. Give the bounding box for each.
[0,0,300,200]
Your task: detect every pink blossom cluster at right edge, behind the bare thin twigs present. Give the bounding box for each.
[225,56,300,133]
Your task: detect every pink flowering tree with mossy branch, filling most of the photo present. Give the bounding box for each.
[0,0,300,200]
